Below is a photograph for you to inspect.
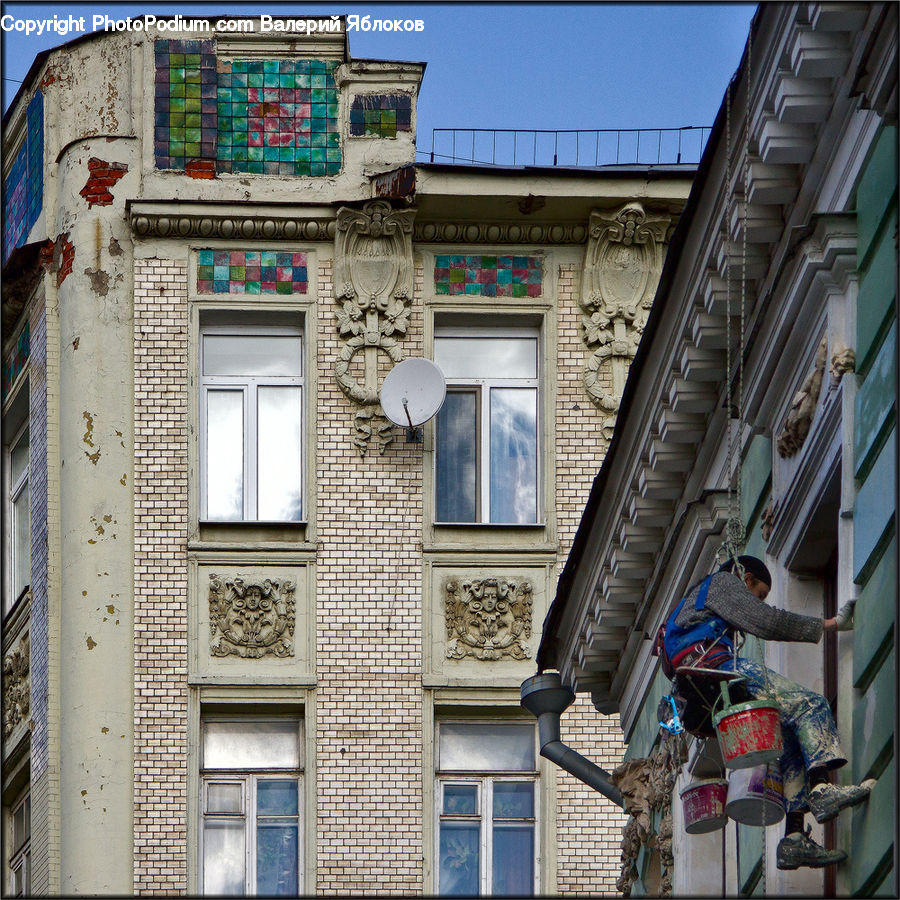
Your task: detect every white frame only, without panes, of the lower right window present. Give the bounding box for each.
[434,718,541,897]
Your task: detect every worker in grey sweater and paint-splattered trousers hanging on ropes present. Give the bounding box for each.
[664,556,874,869]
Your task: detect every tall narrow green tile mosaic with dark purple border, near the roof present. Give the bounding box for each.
[153,40,216,170]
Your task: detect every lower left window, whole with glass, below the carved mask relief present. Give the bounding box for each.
[200,717,302,897]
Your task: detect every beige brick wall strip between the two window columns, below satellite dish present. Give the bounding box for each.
[307,262,423,894]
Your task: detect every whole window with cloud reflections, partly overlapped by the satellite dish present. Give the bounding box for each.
[434,327,539,525]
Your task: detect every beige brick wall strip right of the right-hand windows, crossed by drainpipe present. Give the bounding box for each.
[556,265,627,894]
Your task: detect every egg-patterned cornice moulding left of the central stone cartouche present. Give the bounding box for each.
[130,210,336,241]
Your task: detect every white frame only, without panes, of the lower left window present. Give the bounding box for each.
[198,716,304,897]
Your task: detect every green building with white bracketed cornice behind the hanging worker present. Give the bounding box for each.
[538,3,897,896]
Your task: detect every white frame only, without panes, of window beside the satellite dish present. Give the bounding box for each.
[433,323,544,527]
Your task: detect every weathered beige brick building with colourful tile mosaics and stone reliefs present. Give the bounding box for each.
[3,20,694,895]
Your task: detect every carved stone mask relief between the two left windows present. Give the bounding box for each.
[209,575,295,659]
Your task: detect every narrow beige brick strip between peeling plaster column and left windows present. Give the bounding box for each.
[132,259,188,895]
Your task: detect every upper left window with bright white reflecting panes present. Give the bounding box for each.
[200,325,303,522]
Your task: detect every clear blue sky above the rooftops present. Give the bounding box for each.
[2,0,755,158]
